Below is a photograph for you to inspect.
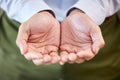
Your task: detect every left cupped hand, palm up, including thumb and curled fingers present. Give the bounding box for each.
[16,11,60,65]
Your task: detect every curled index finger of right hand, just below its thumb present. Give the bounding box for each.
[77,50,95,60]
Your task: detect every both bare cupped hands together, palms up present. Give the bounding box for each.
[16,9,105,65]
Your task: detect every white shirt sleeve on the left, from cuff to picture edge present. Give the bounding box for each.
[0,0,52,23]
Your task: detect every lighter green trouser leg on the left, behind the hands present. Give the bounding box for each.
[0,10,61,80]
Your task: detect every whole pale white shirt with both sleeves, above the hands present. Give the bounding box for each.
[0,0,120,25]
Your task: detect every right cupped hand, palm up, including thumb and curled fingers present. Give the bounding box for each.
[60,9,104,64]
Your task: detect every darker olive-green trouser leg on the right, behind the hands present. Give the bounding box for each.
[62,12,120,80]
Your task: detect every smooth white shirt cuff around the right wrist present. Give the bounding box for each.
[68,0,106,25]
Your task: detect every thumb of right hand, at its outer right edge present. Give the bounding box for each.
[90,27,105,54]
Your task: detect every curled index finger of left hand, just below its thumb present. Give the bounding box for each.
[24,52,43,60]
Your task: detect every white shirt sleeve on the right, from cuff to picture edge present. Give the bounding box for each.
[71,0,120,25]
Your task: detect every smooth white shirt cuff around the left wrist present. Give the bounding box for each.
[14,0,52,23]
